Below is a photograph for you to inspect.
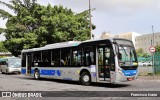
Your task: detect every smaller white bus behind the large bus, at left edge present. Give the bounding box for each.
[0,57,21,74]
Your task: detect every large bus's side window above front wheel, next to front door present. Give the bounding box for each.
[83,46,95,66]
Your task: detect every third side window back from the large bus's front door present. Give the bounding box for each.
[60,48,71,66]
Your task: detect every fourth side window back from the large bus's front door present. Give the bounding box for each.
[51,49,60,66]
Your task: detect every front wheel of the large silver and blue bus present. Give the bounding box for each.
[80,72,91,86]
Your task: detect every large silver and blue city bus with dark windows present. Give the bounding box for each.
[22,38,138,85]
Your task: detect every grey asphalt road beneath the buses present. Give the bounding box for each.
[0,74,160,100]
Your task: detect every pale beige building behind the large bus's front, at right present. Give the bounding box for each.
[101,32,160,54]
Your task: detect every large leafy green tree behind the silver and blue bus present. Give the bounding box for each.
[0,0,95,56]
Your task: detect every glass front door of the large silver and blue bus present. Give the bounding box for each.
[98,46,115,82]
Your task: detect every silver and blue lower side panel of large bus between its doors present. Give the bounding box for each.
[31,67,97,82]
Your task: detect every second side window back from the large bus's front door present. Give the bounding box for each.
[72,49,82,66]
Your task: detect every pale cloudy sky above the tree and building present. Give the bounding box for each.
[0,0,160,39]
